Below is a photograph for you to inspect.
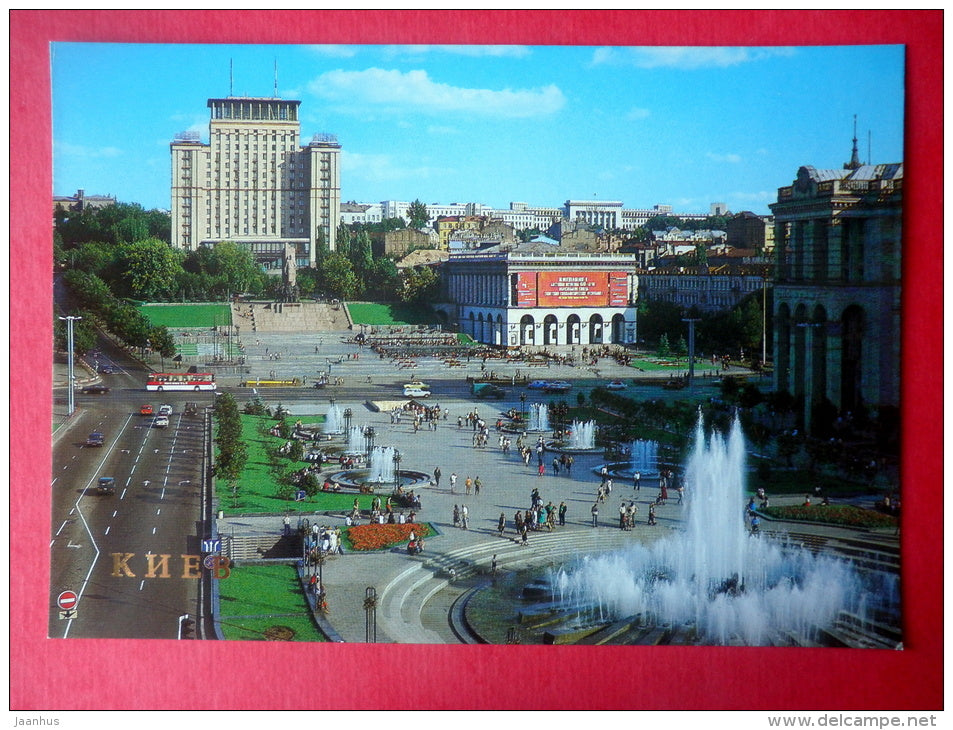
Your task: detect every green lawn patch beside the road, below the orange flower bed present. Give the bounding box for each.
[218,565,327,641]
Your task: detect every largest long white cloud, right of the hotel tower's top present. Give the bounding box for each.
[308,68,566,118]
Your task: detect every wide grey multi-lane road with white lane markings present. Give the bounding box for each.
[49,346,212,638]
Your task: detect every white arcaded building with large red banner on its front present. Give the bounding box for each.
[442,251,638,347]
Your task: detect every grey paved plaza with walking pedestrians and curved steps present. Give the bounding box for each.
[212,332,896,643]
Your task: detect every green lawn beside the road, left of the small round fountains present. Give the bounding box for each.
[216,414,410,514]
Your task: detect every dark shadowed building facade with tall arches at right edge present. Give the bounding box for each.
[771,162,903,432]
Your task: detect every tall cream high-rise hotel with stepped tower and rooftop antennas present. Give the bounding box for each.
[171,96,341,266]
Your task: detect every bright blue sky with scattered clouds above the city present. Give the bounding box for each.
[52,43,904,213]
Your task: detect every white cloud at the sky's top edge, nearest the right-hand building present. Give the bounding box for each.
[591,46,795,70]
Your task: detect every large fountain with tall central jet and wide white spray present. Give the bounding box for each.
[549,412,899,646]
